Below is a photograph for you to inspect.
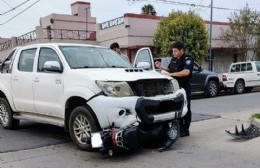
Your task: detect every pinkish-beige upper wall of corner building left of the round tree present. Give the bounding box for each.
[97,14,159,48]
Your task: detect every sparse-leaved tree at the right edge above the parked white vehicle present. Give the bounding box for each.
[220,5,260,61]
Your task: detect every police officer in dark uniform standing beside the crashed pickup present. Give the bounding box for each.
[155,42,194,137]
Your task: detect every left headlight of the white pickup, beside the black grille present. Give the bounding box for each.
[96,81,134,97]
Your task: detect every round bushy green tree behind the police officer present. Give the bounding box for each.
[153,11,209,62]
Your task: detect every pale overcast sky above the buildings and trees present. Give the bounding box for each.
[0,0,260,38]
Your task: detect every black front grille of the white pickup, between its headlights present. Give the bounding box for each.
[128,79,174,97]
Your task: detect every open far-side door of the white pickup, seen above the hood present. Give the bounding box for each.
[134,47,155,71]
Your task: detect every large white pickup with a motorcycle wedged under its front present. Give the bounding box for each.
[0,43,187,153]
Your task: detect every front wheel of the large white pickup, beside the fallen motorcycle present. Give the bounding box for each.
[69,106,99,151]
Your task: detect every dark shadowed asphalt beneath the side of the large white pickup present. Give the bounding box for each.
[0,121,71,153]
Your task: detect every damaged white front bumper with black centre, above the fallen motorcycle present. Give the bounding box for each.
[87,89,187,129]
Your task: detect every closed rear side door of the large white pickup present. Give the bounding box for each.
[11,48,37,112]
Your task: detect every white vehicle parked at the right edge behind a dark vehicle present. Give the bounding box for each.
[219,61,260,94]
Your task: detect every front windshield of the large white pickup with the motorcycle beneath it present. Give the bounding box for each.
[59,46,133,69]
